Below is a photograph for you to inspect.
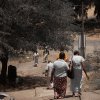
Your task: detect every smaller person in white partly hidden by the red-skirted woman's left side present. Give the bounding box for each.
[45,60,53,89]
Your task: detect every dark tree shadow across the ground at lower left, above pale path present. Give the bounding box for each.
[0,76,47,91]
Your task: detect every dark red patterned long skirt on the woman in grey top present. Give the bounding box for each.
[54,77,67,97]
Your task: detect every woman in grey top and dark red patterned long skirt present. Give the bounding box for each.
[51,52,69,99]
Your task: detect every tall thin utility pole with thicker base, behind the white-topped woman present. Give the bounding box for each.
[80,0,85,58]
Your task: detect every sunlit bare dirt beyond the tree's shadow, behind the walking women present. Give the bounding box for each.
[17,51,58,76]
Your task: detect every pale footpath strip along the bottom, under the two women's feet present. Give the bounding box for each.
[7,87,100,100]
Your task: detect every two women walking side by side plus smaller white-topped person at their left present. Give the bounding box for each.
[46,50,89,99]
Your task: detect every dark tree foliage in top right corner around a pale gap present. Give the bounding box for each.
[71,0,100,31]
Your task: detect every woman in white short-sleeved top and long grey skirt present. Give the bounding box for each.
[70,50,88,96]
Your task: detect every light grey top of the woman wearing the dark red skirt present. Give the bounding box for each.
[53,59,69,77]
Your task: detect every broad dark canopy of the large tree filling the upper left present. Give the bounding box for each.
[0,0,78,49]
